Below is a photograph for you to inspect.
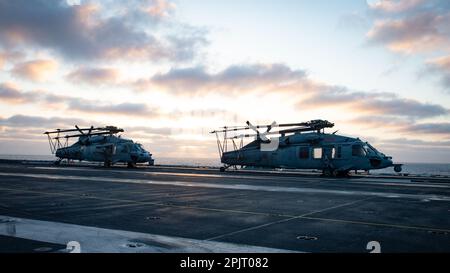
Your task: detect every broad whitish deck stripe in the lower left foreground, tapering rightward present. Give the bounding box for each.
[0,215,293,253]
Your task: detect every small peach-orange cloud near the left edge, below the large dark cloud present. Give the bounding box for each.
[11,60,58,81]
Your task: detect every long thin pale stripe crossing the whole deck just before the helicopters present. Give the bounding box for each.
[0,173,450,201]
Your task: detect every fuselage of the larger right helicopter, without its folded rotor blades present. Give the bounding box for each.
[221,132,401,174]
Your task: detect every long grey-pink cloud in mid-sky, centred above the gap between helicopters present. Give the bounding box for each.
[134,64,306,94]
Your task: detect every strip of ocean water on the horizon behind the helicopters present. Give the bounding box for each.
[0,154,450,176]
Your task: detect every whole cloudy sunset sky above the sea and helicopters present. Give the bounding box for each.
[0,0,450,163]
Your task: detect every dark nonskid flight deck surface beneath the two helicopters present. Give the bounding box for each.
[0,160,450,252]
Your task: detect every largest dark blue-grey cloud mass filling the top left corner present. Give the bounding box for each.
[0,0,204,61]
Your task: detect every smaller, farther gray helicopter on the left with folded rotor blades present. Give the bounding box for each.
[44,125,154,168]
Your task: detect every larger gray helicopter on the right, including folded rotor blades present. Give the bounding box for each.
[211,120,402,176]
